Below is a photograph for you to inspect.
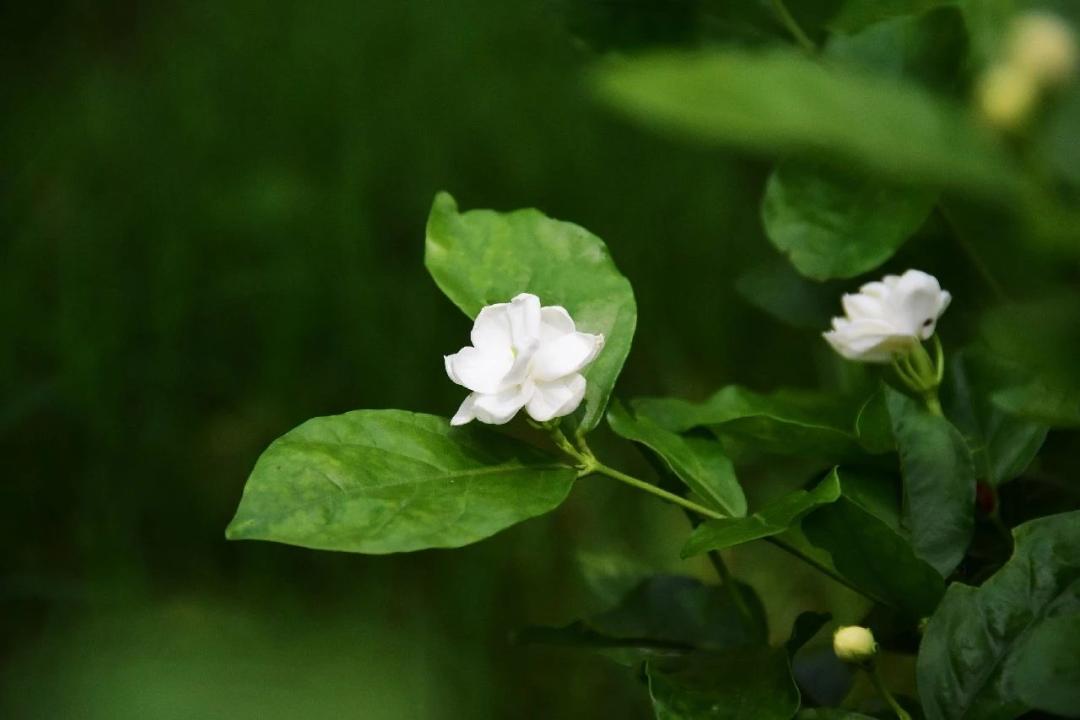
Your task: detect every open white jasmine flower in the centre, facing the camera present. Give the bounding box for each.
[444,293,604,425]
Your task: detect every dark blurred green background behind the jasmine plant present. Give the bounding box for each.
[0,0,1010,719]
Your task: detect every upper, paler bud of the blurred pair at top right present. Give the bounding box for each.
[1007,12,1078,86]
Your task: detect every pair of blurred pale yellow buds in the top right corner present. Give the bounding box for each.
[977,12,1080,131]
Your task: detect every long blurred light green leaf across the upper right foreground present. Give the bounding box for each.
[593,51,1013,193]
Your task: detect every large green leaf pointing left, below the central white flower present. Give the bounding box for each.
[226,410,577,554]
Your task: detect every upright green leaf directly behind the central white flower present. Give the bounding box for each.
[424,192,637,432]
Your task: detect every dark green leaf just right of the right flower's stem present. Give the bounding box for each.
[942,351,1049,486]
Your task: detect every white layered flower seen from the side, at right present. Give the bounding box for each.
[824,270,953,363]
